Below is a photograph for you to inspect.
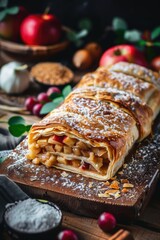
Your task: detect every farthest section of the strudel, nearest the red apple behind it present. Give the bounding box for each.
[77,65,160,119]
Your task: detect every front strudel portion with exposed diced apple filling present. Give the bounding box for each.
[27,88,140,180]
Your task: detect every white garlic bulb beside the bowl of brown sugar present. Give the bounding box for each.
[0,61,29,94]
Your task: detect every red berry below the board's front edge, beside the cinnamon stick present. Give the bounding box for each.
[98,212,116,232]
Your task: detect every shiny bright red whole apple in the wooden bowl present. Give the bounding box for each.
[20,14,62,45]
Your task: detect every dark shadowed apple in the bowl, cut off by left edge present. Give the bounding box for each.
[0,6,28,41]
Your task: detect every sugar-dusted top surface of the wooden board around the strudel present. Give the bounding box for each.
[4,121,160,205]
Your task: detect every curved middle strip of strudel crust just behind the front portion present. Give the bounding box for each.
[74,87,154,140]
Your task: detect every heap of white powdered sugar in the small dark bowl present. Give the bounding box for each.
[5,198,61,233]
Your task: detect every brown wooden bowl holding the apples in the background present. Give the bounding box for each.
[0,39,69,60]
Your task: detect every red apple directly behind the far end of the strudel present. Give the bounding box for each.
[99,44,147,67]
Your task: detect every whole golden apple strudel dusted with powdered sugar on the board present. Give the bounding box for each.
[27,62,160,180]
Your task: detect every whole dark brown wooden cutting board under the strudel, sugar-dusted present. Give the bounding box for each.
[0,118,160,222]
